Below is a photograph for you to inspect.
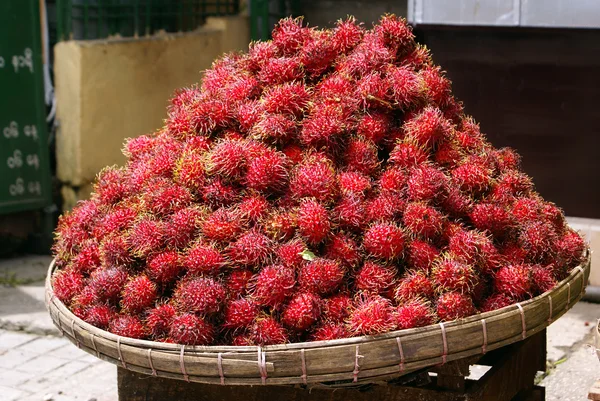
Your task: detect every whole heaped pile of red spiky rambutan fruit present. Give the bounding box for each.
[53,15,586,345]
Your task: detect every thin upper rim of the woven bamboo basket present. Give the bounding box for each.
[45,248,591,353]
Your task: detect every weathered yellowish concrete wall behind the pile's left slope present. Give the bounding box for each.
[54,17,250,209]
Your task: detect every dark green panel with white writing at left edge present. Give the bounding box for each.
[0,0,51,213]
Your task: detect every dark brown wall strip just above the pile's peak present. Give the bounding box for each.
[299,0,407,27]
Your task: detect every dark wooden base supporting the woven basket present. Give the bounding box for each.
[118,330,546,401]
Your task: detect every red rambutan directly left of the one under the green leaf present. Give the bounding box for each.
[251,265,296,307]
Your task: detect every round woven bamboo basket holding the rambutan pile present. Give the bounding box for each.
[46,251,590,387]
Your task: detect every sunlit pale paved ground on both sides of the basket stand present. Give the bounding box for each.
[0,256,600,401]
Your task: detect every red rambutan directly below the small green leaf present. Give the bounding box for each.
[298,258,345,295]
